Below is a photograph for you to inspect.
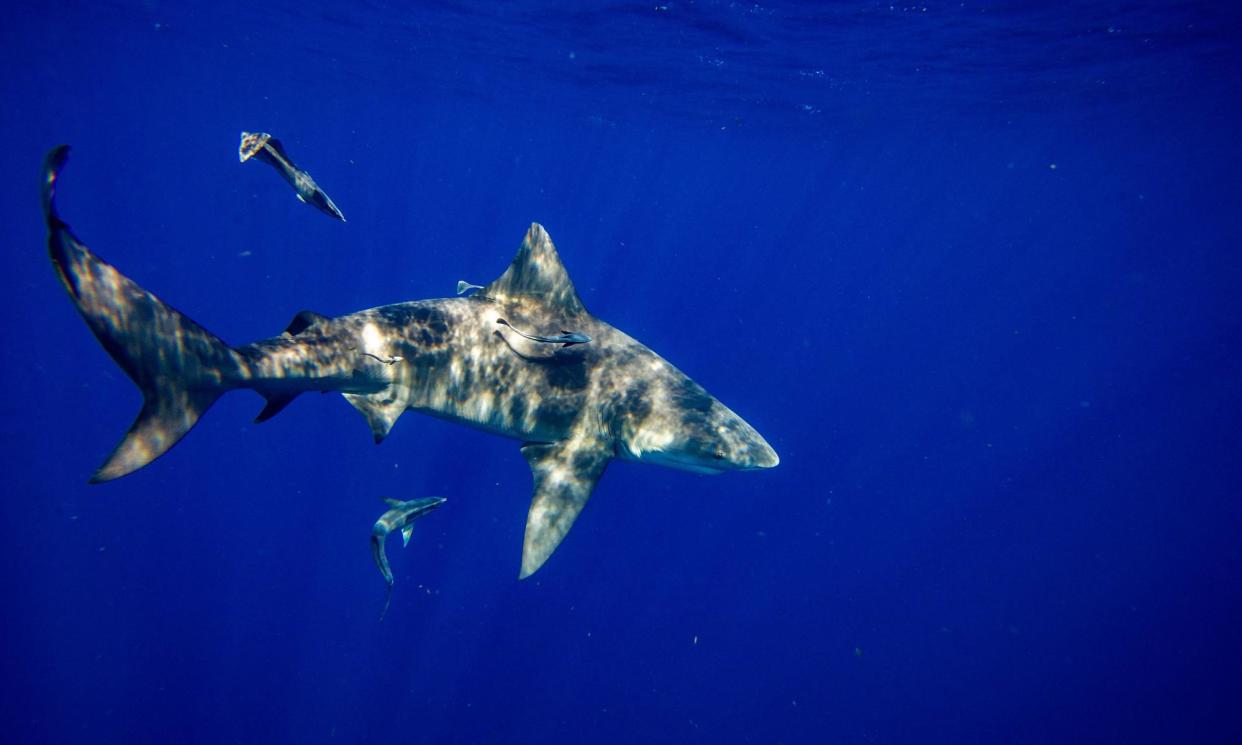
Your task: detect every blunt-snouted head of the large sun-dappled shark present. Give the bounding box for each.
[620,374,780,473]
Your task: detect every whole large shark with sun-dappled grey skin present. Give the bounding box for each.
[43,147,779,577]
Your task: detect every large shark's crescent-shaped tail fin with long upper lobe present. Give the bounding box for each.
[42,145,245,482]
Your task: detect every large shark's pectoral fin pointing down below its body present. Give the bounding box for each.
[519,438,614,579]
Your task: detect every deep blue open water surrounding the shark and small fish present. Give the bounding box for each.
[0,0,1242,744]
